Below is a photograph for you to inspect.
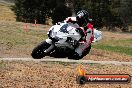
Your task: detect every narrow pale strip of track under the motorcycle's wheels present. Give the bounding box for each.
[0,58,132,65]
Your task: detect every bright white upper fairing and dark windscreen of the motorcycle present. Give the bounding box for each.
[50,23,80,41]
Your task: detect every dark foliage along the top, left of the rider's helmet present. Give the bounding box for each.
[13,0,70,24]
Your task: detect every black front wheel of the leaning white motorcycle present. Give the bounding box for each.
[31,41,51,59]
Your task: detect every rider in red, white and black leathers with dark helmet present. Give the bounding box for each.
[66,10,94,58]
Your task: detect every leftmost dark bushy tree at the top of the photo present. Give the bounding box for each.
[14,0,48,23]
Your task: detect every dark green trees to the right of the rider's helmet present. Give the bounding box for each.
[73,0,132,31]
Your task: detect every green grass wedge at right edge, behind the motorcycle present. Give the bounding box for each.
[93,39,132,56]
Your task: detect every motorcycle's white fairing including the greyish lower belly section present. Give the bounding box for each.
[49,23,81,49]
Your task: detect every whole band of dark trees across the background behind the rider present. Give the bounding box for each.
[14,0,132,31]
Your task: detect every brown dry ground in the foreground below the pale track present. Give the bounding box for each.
[0,61,132,88]
